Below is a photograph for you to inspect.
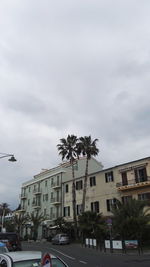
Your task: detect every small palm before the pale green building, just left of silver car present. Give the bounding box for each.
[29,212,46,241]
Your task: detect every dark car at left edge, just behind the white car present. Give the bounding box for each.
[0,232,22,251]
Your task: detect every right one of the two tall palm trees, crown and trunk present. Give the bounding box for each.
[77,135,99,212]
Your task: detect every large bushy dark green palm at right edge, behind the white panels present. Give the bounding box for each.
[112,199,150,243]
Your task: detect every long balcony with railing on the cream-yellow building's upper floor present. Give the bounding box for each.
[116,176,150,191]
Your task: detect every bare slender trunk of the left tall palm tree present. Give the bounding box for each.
[71,160,77,239]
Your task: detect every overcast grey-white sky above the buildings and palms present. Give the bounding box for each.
[0,0,150,208]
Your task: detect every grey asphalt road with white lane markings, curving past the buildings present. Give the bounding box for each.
[22,242,150,267]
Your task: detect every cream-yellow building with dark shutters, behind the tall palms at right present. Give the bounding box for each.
[62,157,150,221]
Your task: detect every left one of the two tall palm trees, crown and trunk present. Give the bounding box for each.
[57,135,78,237]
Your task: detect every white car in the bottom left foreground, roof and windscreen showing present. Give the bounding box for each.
[0,251,68,267]
